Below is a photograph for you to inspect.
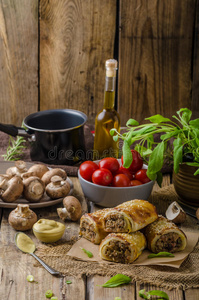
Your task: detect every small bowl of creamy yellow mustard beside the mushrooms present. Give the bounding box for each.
[33,219,65,243]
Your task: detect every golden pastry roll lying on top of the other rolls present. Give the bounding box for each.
[104,199,158,233]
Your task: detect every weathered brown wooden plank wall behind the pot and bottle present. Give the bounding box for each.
[0,0,199,125]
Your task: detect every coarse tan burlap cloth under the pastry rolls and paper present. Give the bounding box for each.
[36,185,199,289]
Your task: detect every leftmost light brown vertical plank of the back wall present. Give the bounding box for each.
[0,0,38,125]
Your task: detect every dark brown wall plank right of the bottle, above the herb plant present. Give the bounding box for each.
[118,0,199,125]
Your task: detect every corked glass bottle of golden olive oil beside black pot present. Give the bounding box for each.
[93,59,120,160]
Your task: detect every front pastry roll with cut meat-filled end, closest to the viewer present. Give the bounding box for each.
[99,231,146,264]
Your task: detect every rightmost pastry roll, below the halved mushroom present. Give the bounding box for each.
[143,216,187,253]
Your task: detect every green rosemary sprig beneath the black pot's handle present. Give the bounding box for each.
[2,136,27,161]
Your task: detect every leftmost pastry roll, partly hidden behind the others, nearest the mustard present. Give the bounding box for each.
[79,208,109,244]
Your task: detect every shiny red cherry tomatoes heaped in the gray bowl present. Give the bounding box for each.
[79,150,150,187]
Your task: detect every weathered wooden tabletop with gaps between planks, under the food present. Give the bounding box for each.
[0,175,199,300]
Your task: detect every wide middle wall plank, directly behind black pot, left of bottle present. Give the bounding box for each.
[40,0,116,123]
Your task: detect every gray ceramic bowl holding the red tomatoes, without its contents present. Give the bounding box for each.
[78,160,154,207]
